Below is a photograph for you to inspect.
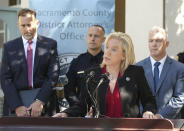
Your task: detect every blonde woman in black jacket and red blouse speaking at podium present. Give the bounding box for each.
[54,32,156,118]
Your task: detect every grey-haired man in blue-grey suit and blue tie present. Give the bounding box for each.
[137,26,184,119]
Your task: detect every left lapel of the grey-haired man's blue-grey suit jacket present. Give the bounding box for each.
[144,57,155,95]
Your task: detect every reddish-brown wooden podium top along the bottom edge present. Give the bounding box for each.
[0,117,177,131]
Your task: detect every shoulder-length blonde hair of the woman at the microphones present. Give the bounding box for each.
[101,32,135,73]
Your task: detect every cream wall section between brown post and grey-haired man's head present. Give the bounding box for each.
[125,0,163,61]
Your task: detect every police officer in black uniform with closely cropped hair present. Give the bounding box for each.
[64,25,105,106]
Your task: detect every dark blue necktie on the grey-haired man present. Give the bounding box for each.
[154,62,160,93]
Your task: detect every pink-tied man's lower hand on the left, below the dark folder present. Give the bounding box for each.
[15,106,30,117]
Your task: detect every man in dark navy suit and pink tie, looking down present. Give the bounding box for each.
[1,9,59,117]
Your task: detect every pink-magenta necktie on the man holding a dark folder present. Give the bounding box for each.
[27,40,33,89]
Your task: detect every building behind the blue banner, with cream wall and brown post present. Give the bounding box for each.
[0,0,184,61]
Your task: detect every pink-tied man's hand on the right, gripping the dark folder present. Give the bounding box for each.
[28,100,43,117]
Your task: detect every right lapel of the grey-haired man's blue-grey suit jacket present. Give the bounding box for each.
[156,56,172,93]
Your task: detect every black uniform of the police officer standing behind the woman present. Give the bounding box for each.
[64,51,103,106]
